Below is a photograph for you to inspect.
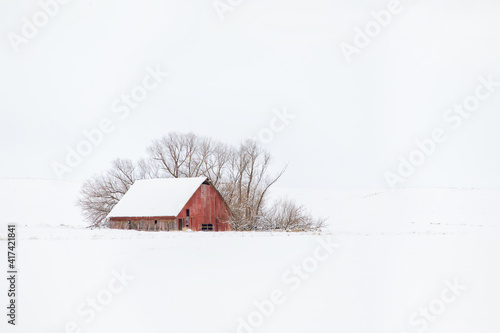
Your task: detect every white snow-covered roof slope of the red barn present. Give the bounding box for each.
[108,177,207,217]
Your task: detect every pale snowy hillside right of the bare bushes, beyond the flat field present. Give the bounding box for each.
[272,188,500,233]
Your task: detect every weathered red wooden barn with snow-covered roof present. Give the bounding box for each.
[108,177,232,231]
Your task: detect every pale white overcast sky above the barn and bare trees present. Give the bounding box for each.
[0,0,500,189]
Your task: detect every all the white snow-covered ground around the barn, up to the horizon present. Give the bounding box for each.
[0,180,500,333]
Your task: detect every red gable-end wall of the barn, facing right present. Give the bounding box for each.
[177,184,232,231]
